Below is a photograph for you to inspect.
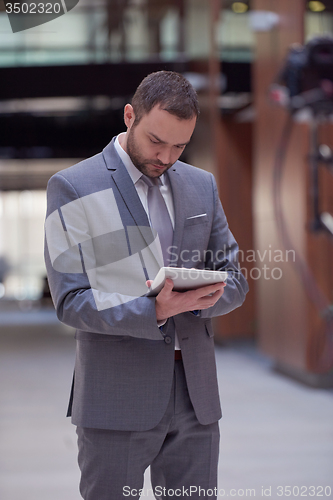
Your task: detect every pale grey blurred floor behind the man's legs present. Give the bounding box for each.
[0,313,333,500]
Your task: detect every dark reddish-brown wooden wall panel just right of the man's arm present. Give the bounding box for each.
[216,116,255,339]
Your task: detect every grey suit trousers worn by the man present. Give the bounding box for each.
[77,361,219,500]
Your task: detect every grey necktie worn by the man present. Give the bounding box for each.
[141,175,173,266]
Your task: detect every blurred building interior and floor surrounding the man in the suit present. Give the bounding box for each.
[0,0,333,500]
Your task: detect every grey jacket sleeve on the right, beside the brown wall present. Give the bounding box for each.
[200,176,249,318]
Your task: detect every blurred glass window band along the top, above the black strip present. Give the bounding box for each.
[0,0,254,66]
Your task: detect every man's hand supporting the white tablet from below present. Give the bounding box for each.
[146,278,226,321]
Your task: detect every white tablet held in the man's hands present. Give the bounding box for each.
[146,267,228,297]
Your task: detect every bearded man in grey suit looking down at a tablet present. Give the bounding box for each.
[45,71,248,500]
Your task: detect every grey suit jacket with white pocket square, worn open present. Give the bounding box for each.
[45,139,248,431]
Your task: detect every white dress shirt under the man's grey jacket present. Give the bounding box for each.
[114,132,180,349]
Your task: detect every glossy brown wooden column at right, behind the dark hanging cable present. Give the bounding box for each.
[251,0,333,374]
